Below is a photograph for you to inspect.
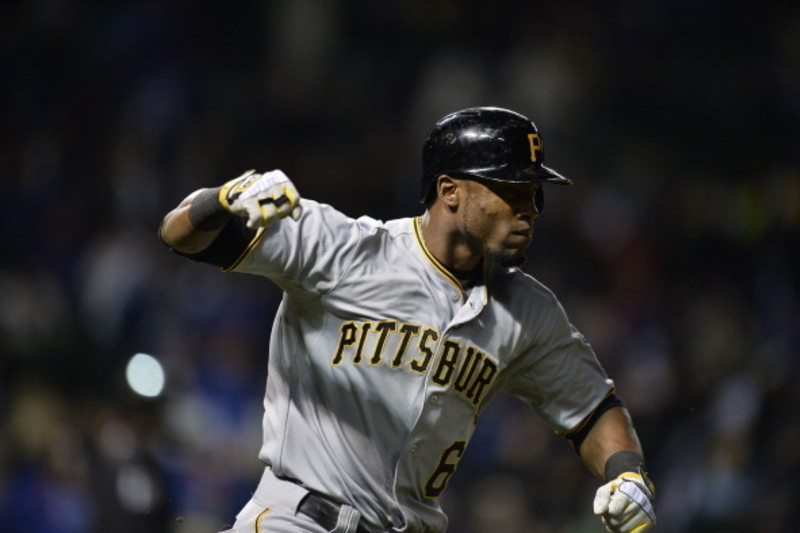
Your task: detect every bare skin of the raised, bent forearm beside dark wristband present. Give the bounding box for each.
[159,189,230,253]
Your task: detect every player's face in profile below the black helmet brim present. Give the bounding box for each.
[462,180,541,266]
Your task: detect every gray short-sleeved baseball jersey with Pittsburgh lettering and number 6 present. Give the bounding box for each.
[231,199,613,532]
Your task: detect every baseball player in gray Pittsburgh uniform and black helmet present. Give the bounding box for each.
[159,108,655,533]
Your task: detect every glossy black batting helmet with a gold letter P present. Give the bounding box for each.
[422,107,572,203]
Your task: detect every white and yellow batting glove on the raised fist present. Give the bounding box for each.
[219,170,303,229]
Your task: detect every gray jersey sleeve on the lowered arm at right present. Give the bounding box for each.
[504,294,614,435]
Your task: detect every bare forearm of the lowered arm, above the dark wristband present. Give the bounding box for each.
[580,407,642,479]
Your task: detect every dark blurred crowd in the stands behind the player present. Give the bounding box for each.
[0,0,800,533]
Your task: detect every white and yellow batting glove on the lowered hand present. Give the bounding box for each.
[594,472,656,533]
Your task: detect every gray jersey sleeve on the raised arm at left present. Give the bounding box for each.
[232,199,363,294]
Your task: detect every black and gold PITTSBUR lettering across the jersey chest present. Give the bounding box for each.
[331,320,498,405]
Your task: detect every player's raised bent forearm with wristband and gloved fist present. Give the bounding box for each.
[159,170,302,254]
